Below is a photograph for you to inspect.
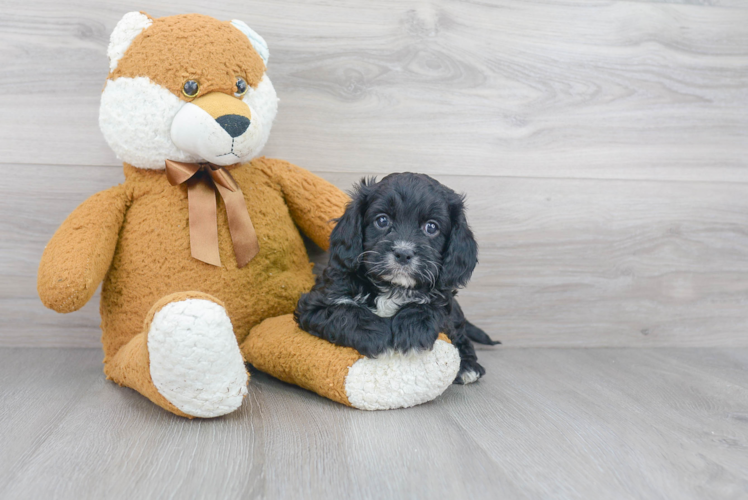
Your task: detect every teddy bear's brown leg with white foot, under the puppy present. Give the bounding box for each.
[241,314,460,410]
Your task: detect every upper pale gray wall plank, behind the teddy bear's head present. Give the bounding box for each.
[0,0,748,182]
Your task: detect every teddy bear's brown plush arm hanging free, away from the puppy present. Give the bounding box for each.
[37,185,128,313]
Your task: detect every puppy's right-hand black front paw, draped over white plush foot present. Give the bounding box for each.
[392,304,447,352]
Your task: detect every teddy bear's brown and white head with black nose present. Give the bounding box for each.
[99,12,278,169]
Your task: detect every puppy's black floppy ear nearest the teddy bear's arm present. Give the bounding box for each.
[330,178,376,272]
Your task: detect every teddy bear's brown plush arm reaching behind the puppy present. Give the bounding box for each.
[268,162,350,250]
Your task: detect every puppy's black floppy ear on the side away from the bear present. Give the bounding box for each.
[438,193,478,290]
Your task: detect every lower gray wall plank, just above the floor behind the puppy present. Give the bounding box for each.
[0,165,748,347]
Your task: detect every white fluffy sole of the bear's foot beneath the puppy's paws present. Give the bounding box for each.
[345,340,460,410]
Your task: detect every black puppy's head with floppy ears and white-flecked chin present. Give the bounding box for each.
[330,173,478,290]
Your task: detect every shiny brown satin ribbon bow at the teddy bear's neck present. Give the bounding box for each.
[166,160,260,267]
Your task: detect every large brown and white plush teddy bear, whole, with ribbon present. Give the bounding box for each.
[38,12,459,418]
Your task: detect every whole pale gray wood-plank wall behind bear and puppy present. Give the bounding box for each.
[0,0,748,347]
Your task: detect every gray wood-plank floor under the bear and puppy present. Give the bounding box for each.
[0,348,748,500]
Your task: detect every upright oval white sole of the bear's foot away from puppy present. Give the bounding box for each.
[148,299,247,418]
